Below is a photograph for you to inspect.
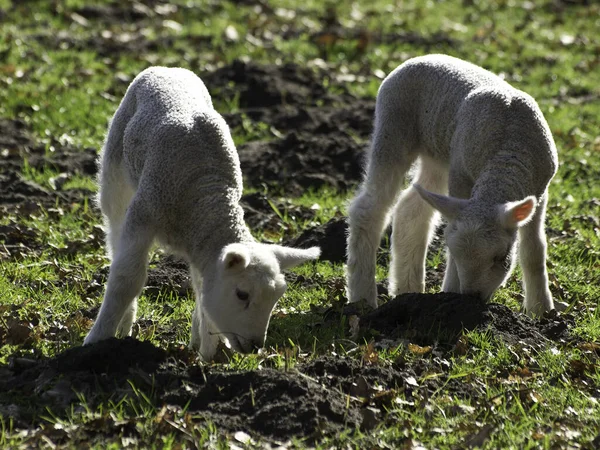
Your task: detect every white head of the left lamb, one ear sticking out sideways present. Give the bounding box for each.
[203,243,321,353]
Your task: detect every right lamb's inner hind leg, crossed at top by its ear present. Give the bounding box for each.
[389,157,448,296]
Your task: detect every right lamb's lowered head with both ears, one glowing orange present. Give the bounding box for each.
[415,186,537,300]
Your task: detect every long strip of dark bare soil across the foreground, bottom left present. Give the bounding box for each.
[0,338,479,443]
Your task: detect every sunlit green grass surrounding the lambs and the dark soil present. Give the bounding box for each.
[0,0,600,448]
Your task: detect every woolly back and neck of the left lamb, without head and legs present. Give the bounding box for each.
[117,68,250,254]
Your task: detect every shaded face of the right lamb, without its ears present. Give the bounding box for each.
[446,221,517,300]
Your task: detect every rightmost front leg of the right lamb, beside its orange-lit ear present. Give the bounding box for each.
[519,195,554,315]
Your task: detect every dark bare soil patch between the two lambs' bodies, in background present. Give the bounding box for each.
[203,61,375,195]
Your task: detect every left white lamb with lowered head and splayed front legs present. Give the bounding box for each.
[84,67,320,360]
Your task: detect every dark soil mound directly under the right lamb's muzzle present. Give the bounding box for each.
[283,293,575,349]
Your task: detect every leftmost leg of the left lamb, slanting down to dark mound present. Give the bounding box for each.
[84,199,154,344]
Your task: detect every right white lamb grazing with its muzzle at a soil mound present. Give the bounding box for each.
[347,55,558,315]
